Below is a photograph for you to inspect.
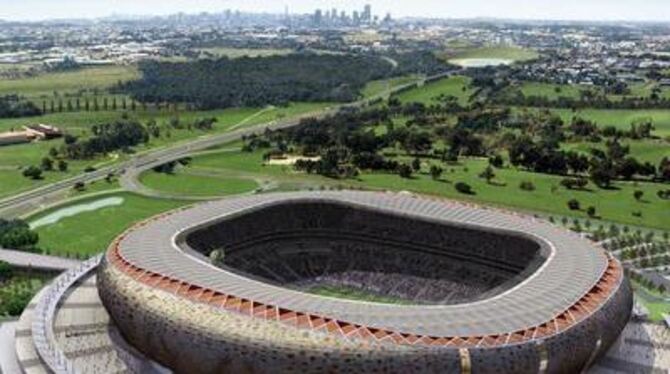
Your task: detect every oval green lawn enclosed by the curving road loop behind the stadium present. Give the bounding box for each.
[140,171,258,197]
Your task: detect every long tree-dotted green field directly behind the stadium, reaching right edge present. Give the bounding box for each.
[192,148,670,230]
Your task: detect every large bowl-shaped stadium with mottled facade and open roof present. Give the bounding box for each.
[17,191,633,373]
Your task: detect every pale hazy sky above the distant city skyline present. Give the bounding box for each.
[0,0,670,21]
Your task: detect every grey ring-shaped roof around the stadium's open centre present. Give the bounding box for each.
[118,191,608,336]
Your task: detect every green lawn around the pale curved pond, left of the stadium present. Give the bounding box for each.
[27,192,188,256]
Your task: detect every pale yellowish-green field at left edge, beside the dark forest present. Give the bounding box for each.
[0,65,139,101]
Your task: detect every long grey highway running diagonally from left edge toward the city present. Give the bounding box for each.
[0,72,452,218]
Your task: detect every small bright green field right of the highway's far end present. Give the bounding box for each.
[396,76,472,105]
